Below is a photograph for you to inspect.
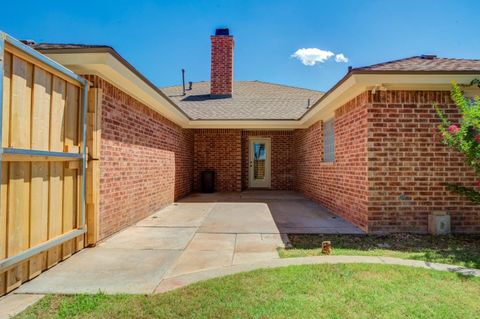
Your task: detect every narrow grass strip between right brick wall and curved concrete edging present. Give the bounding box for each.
[279,234,480,269]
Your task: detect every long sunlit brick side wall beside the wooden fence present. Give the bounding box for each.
[90,77,193,238]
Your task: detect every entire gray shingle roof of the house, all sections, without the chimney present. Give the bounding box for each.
[28,41,480,120]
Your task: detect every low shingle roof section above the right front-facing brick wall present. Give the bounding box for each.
[353,55,480,72]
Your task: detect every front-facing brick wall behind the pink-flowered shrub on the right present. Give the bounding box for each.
[368,91,480,232]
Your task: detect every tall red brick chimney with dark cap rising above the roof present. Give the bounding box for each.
[210,29,233,98]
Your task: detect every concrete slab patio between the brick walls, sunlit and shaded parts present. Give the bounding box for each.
[16,191,362,294]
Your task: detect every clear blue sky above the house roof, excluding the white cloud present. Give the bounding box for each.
[0,0,480,90]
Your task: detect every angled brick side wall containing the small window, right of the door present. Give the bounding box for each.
[294,93,368,230]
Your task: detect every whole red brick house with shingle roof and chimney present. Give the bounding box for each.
[33,29,480,239]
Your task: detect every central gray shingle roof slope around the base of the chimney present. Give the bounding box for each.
[161,81,323,120]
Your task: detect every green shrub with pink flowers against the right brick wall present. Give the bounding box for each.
[434,83,480,203]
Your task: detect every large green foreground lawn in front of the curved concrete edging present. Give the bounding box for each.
[18,264,480,319]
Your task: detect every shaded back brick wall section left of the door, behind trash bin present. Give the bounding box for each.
[193,129,242,192]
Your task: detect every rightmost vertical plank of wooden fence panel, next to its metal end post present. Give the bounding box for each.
[63,83,79,258]
